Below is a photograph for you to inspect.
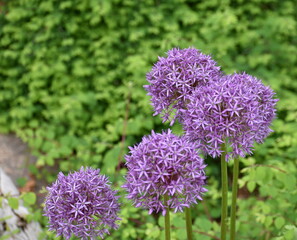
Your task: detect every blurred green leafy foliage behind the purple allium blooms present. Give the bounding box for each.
[0,0,297,240]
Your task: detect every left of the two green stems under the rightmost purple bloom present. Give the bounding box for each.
[221,144,228,240]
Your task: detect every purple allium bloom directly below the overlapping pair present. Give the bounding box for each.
[123,130,207,215]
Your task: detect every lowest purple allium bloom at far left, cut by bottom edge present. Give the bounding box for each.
[44,167,119,240]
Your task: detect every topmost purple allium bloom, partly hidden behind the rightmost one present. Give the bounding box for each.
[144,48,221,123]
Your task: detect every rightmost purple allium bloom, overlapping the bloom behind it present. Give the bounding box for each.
[181,73,277,157]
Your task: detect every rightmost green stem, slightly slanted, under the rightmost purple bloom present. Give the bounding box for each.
[230,158,239,240]
